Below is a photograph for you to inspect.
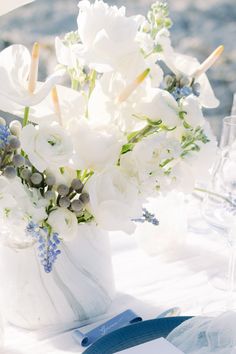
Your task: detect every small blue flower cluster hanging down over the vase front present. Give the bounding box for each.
[26,221,61,273]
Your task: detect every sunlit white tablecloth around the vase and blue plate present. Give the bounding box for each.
[0,196,228,354]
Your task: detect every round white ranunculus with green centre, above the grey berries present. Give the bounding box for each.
[20,123,73,172]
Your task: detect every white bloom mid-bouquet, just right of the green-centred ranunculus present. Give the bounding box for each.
[69,118,124,171]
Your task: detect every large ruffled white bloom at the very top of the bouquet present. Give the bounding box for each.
[77,0,144,72]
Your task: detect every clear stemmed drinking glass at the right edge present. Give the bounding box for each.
[203,115,236,304]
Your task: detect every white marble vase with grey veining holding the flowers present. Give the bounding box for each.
[0,225,114,329]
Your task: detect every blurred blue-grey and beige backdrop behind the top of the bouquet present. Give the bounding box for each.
[0,0,236,136]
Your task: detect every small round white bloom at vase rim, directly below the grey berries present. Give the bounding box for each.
[48,208,78,241]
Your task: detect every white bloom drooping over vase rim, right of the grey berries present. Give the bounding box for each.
[85,167,142,234]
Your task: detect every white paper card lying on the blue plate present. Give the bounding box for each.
[117,338,184,354]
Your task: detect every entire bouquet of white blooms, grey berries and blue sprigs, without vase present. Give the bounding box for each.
[0,0,223,272]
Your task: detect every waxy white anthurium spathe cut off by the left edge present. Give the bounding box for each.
[0,45,64,112]
